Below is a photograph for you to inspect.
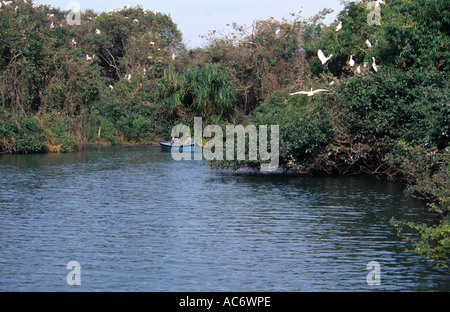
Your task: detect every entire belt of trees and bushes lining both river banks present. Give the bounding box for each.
[0,0,450,270]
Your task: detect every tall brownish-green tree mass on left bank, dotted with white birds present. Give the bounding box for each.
[0,0,183,152]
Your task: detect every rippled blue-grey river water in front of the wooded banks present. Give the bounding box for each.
[0,147,450,292]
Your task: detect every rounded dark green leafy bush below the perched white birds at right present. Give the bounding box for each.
[338,70,450,152]
